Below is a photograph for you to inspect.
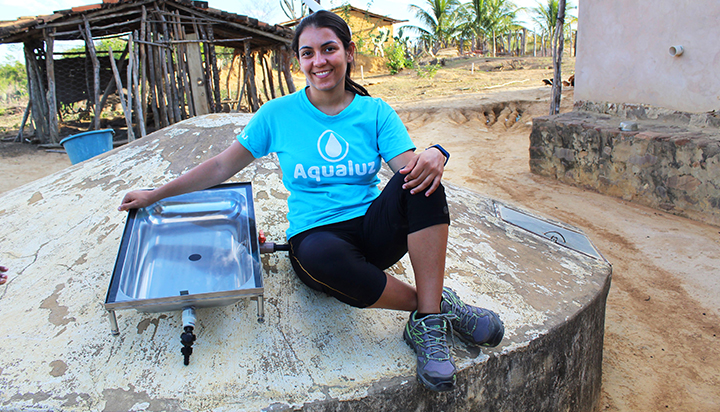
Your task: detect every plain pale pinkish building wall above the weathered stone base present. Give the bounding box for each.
[575,0,720,113]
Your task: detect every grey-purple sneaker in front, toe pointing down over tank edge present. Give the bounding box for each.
[403,312,456,392]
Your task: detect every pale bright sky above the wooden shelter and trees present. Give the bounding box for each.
[0,0,556,64]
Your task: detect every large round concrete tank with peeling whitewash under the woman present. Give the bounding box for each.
[0,114,611,411]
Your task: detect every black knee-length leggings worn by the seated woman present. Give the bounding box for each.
[289,173,450,308]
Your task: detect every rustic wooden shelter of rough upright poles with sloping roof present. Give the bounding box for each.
[0,0,295,143]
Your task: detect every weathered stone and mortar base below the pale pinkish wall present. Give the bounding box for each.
[530,106,720,225]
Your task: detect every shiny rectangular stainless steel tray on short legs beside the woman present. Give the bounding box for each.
[105,183,263,332]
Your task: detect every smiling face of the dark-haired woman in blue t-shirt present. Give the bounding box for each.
[298,26,355,96]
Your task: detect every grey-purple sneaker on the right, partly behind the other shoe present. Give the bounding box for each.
[440,286,505,347]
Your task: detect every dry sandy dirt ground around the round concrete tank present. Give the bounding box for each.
[0,58,720,411]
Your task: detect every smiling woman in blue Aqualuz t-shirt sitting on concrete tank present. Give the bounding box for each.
[119,11,504,391]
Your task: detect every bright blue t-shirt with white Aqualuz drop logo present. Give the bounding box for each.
[237,89,415,239]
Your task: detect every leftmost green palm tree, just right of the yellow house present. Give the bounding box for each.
[403,0,460,54]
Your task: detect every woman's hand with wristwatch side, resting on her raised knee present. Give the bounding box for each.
[399,148,445,196]
